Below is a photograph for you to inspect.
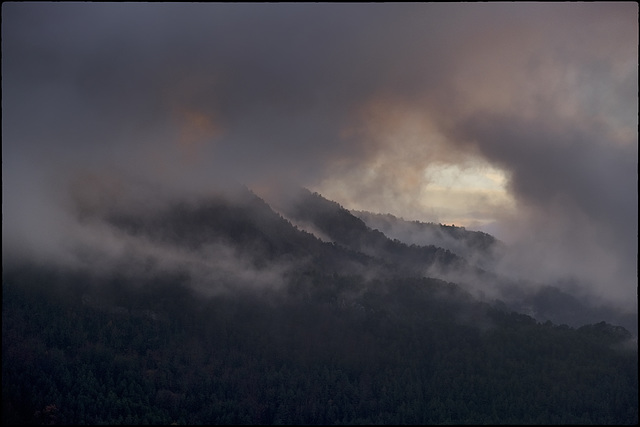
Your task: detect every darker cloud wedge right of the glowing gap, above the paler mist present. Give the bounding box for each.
[459,115,637,241]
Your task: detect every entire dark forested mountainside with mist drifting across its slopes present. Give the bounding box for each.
[2,189,638,425]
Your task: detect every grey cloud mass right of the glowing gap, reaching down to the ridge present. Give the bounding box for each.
[448,115,638,310]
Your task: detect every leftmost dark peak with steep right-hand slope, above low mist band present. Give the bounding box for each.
[76,187,384,288]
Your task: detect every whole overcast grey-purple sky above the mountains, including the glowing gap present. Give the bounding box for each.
[2,2,638,310]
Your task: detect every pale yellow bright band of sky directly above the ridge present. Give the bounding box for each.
[313,160,515,231]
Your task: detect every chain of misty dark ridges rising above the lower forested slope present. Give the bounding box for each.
[57,186,637,336]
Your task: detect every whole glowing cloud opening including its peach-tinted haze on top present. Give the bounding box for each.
[313,98,515,231]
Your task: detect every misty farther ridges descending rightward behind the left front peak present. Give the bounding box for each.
[282,189,638,336]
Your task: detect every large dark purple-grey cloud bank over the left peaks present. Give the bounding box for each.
[2,3,460,254]
